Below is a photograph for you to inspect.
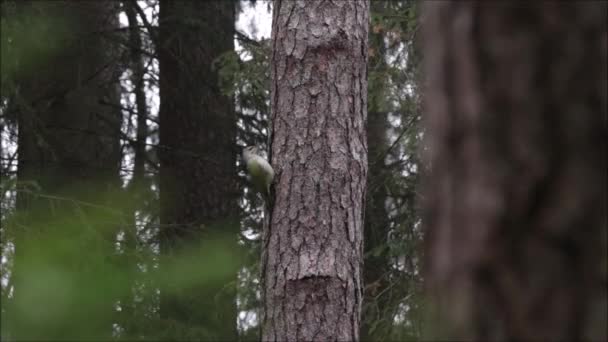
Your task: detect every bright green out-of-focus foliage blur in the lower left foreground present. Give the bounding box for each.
[2,186,240,340]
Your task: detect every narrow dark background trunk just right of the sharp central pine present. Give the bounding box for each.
[361,1,393,341]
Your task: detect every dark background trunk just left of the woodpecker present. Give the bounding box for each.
[159,1,239,340]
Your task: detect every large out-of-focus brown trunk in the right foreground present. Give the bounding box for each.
[424,2,608,341]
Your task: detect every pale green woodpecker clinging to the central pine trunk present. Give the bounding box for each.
[243,146,274,207]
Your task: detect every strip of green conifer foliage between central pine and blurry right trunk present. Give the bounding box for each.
[362,1,424,340]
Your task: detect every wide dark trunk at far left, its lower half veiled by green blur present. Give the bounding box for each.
[7,1,121,340]
